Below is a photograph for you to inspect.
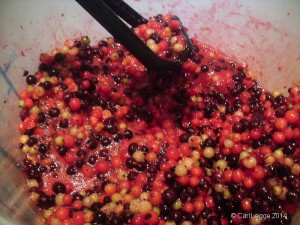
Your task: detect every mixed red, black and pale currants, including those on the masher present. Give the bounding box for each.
[19,14,300,225]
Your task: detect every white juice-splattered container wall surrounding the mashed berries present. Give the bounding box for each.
[0,0,300,224]
